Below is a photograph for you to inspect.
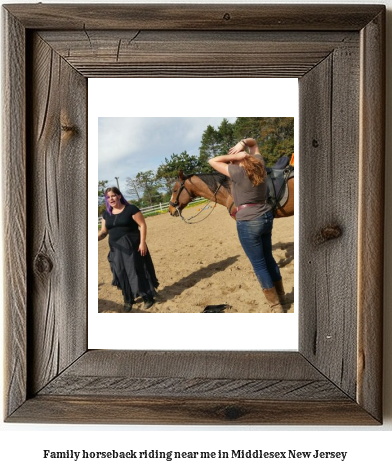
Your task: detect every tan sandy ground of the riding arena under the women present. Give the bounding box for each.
[98,205,294,313]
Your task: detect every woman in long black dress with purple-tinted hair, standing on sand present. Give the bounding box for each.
[98,187,159,312]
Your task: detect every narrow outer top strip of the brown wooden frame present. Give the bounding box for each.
[5,4,380,31]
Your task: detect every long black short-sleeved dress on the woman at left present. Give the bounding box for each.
[102,204,159,304]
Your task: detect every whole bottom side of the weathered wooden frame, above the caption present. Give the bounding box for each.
[9,350,377,425]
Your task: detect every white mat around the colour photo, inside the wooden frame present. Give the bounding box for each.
[88,78,299,350]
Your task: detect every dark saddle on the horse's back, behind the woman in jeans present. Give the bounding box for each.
[267,156,294,214]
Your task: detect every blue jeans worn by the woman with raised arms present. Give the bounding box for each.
[237,211,282,289]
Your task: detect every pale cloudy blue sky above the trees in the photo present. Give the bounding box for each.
[98,117,236,194]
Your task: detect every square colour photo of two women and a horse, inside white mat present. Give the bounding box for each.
[98,117,294,313]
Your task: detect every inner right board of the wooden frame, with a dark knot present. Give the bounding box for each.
[299,38,359,398]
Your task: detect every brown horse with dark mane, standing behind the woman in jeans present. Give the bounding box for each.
[169,170,294,219]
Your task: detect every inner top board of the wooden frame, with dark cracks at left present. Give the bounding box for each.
[40,30,358,77]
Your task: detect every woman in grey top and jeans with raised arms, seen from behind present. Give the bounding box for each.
[209,138,285,313]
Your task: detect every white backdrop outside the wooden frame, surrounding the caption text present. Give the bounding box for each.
[0,0,392,474]
